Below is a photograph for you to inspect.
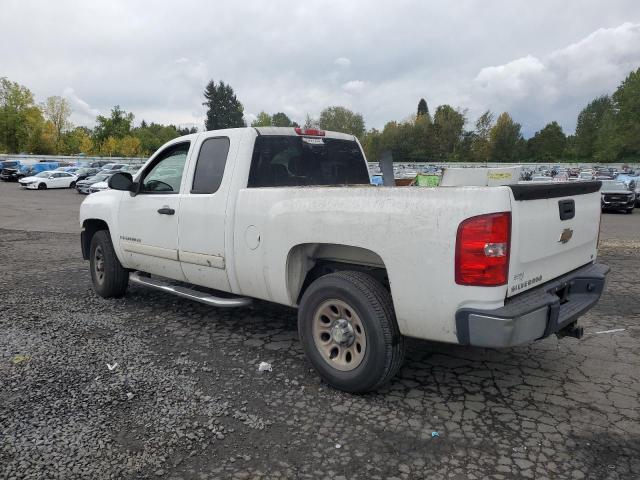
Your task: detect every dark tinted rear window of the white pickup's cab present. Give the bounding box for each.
[247,135,370,188]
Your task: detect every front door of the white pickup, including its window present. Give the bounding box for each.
[117,141,192,280]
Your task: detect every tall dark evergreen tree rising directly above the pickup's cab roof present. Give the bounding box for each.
[203,80,246,130]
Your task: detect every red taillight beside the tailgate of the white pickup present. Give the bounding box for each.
[456,212,511,287]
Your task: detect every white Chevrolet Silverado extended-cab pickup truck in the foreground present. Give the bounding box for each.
[80,128,609,392]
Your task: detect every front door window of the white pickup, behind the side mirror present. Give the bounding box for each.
[140,142,189,193]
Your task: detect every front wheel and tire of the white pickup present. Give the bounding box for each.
[89,230,129,298]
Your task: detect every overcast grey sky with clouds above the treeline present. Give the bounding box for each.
[0,0,640,137]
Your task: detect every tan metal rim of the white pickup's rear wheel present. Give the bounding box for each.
[313,299,367,371]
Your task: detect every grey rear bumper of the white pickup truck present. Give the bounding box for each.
[456,263,609,348]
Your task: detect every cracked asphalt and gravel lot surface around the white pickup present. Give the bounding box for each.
[0,182,640,479]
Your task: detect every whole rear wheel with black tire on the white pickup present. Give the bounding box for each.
[298,271,405,393]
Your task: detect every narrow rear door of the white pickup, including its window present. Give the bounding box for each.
[178,132,236,291]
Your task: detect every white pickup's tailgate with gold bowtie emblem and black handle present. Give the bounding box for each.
[507,181,601,296]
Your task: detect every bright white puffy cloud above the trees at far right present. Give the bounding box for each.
[472,22,640,133]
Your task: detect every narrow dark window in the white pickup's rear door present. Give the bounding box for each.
[191,137,229,193]
